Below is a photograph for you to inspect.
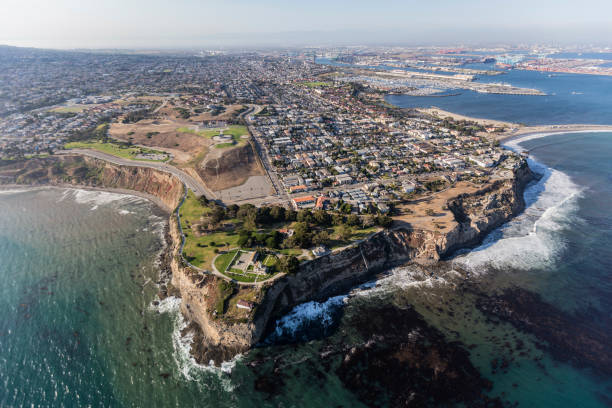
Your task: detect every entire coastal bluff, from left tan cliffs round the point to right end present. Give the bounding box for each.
[0,155,535,364]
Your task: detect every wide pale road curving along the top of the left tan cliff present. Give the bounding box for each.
[58,149,217,200]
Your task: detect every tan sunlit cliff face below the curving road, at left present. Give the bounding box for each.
[0,155,183,211]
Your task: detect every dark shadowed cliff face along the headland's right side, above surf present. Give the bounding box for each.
[253,162,534,340]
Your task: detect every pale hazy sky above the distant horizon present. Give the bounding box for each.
[0,0,612,49]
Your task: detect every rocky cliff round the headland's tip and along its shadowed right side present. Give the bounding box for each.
[173,163,533,362]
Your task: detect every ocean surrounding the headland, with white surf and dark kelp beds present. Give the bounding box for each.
[0,73,612,407]
